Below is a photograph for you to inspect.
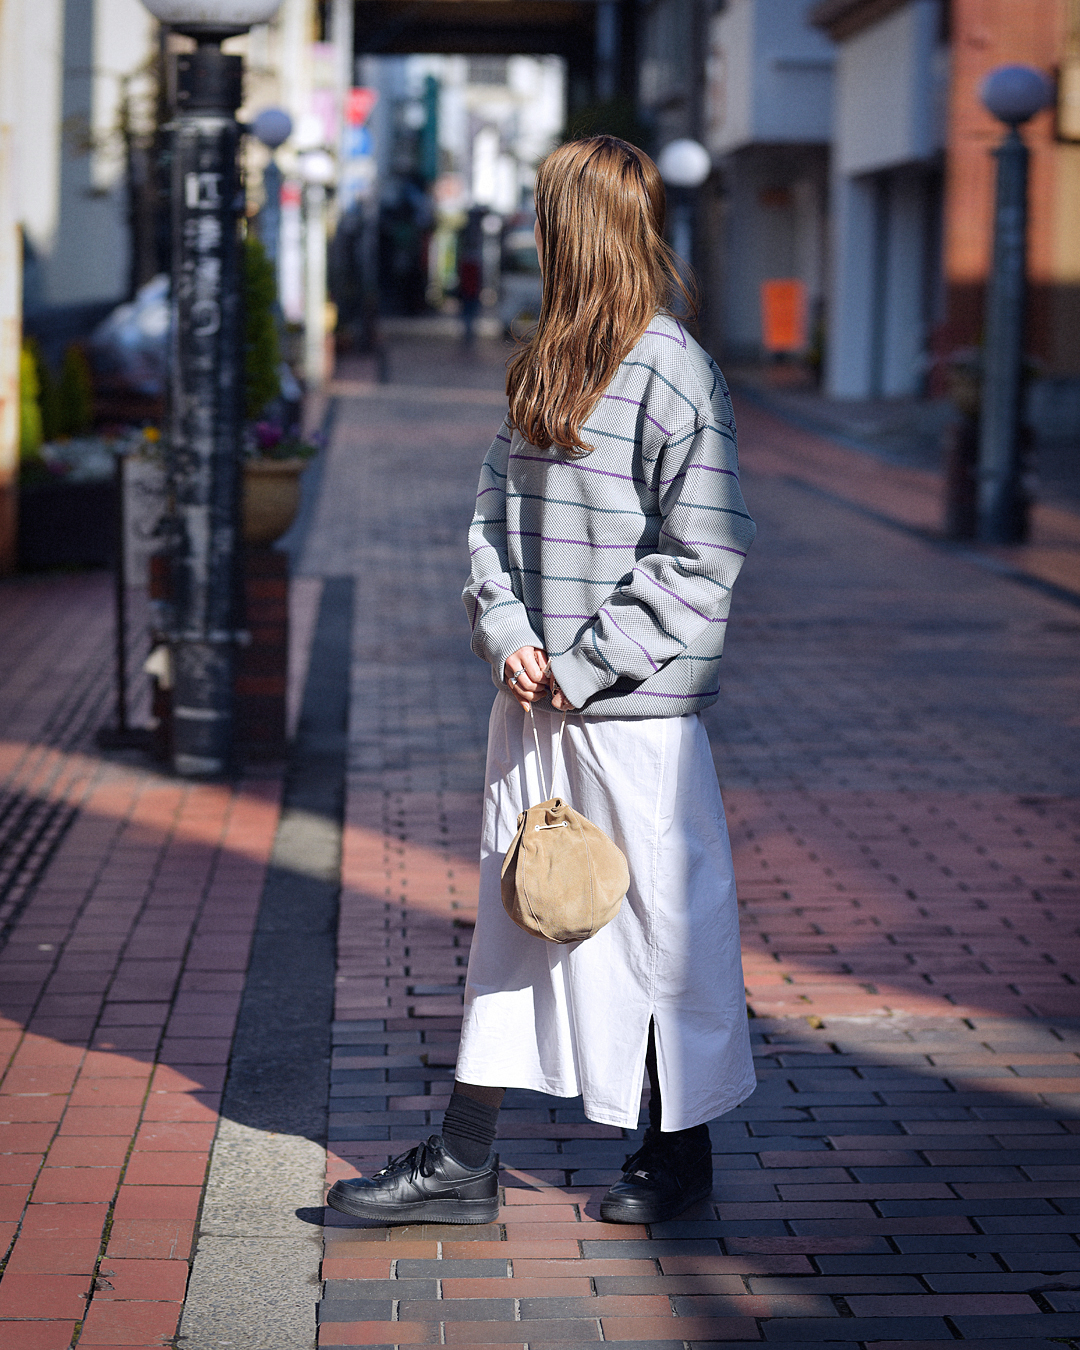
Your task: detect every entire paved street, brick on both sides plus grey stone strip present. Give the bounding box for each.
[0,329,1080,1350]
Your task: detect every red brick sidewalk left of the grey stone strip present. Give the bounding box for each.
[0,576,278,1350]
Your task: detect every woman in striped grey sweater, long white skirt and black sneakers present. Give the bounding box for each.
[329,136,755,1223]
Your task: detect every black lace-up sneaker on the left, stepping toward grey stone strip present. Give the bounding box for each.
[327,1134,498,1223]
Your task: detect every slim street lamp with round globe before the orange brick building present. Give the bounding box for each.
[979,58,1053,544]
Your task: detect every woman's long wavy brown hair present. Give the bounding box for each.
[506,136,694,454]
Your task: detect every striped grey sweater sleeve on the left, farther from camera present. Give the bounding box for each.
[462,421,544,683]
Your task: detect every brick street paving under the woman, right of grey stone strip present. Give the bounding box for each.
[304,334,1080,1350]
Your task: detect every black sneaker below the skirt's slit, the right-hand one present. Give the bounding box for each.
[599,1130,713,1223]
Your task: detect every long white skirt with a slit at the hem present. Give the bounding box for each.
[458,693,755,1130]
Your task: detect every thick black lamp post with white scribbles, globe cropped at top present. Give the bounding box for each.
[143,0,279,776]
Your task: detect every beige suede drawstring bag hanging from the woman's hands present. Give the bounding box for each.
[502,706,630,942]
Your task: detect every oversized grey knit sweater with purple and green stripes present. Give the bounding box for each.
[463,315,755,717]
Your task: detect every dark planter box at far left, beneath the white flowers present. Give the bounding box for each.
[19,481,115,571]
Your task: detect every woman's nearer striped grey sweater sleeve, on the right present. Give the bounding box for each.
[551,402,756,707]
